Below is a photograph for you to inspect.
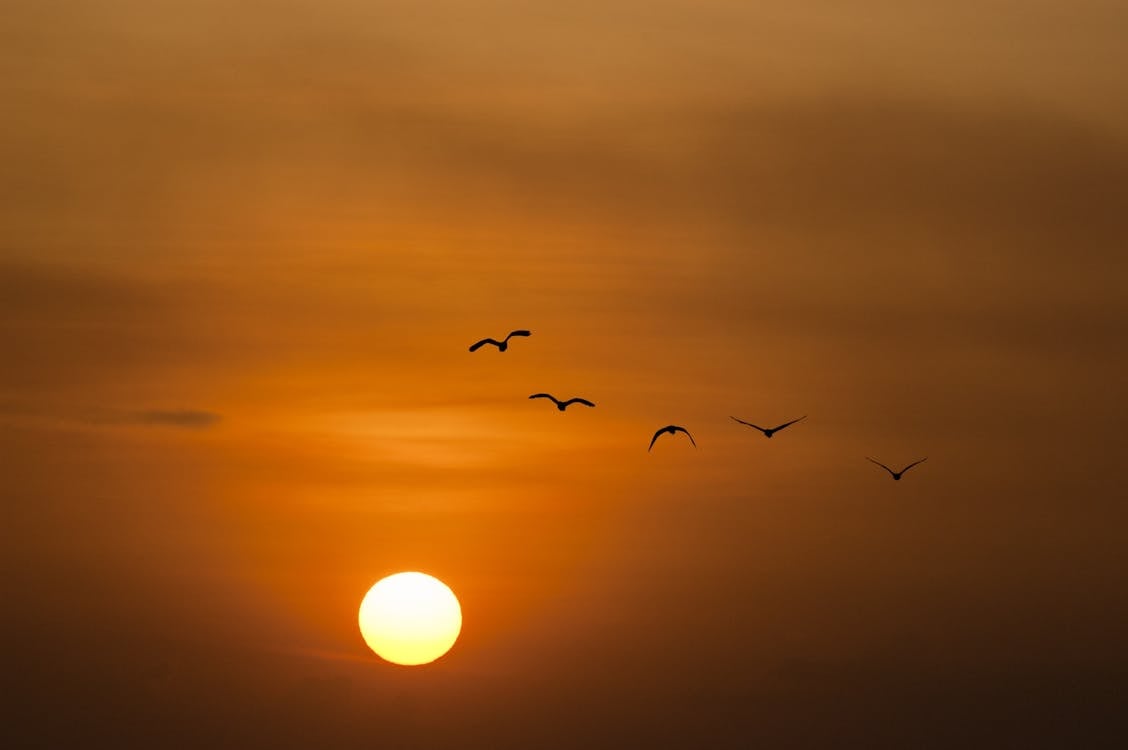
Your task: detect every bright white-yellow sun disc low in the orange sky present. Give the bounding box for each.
[359,572,462,667]
